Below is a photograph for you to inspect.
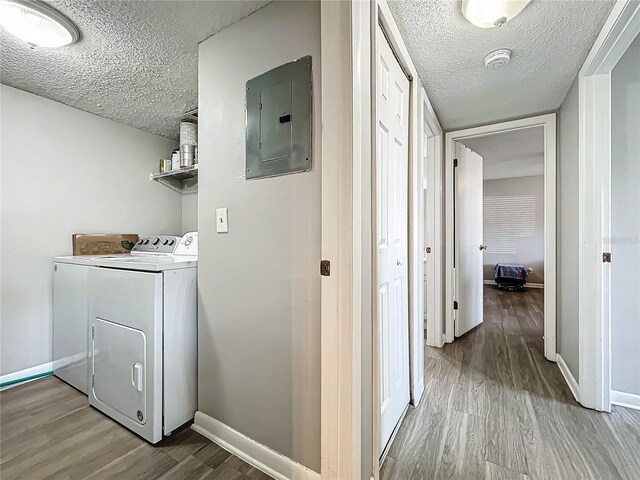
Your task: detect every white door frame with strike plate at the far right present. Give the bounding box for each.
[578,0,640,412]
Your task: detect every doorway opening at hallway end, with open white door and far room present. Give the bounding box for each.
[454,126,544,338]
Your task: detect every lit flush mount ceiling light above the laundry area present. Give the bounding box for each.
[0,0,80,48]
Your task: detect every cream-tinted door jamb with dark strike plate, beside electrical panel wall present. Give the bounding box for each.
[318,2,360,480]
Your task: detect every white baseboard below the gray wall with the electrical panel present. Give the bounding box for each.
[191,411,320,480]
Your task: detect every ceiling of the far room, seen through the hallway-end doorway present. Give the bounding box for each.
[461,127,544,180]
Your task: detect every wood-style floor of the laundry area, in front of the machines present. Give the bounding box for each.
[0,377,271,480]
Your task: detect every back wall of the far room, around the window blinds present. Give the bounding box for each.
[483,175,544,283]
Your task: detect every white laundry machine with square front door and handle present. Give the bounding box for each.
[89,232,198,443]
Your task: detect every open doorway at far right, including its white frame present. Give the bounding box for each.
[577,1,640,412]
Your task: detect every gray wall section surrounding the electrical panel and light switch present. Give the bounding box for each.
[198,2,321,471]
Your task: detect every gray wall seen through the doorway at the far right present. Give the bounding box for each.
[611,32,640,395]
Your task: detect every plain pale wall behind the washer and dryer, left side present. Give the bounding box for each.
[0,85,182,375]
